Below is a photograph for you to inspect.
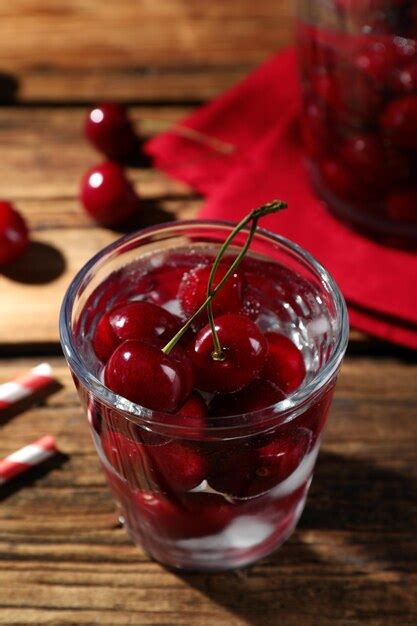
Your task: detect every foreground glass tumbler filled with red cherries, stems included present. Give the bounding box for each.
[61,201,348,571]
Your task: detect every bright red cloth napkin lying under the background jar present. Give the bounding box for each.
[147,49,417,349]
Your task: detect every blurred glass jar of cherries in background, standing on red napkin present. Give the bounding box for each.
[297,0,417,247]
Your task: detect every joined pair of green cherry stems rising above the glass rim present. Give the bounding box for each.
[162,200,287,360]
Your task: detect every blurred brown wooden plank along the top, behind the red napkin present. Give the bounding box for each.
[0,0,293,102]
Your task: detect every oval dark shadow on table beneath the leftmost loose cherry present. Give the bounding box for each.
[0,241,66,285]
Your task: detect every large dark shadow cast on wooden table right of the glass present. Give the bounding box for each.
[178,452,417,626]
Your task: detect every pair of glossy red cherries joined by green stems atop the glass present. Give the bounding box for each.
[102,201,286,413]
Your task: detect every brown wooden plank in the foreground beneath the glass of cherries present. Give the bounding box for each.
[0,357,417,626]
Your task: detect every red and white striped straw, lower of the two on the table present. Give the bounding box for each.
[0,435,58,485]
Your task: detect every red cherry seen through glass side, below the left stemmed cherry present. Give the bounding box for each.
[148,441,207,492]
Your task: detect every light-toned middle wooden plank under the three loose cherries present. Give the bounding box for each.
[0,107,201,344]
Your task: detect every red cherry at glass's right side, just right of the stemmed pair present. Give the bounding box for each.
[262,332,306,393]
